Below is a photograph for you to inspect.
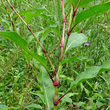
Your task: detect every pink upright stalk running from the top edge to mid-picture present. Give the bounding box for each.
[60,0,66,61]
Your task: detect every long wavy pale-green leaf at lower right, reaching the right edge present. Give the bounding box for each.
[70,61,110,89]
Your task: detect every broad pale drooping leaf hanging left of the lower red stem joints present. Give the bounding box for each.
[38,67,54,110]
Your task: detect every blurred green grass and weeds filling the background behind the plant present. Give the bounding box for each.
[0,0,110,110]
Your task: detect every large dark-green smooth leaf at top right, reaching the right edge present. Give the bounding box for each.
[74,2,110,25]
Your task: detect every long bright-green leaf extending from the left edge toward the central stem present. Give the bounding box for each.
[0,32,47,69]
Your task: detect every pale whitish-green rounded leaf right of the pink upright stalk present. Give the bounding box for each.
[66,32,88,51]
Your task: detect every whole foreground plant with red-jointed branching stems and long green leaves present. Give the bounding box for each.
[0,0,110,110]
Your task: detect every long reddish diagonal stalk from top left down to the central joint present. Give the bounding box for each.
[7,0,56,74]
